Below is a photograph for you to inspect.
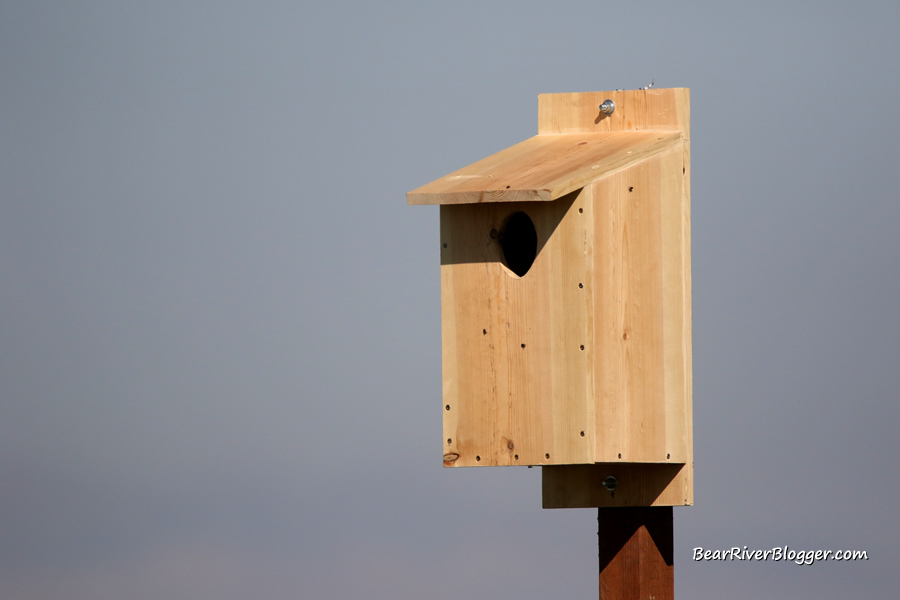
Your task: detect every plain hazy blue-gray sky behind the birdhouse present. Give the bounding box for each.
[0,1,900,600]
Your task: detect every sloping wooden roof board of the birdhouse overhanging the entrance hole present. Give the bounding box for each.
[406,131,682,204]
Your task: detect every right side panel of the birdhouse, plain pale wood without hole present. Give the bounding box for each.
[591,149,691,463]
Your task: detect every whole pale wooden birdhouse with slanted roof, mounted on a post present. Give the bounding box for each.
[407,89,693,508]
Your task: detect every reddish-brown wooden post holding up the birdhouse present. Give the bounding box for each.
[597,506,675,600]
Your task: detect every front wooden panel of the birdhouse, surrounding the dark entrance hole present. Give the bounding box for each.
[441,189,595,466]
